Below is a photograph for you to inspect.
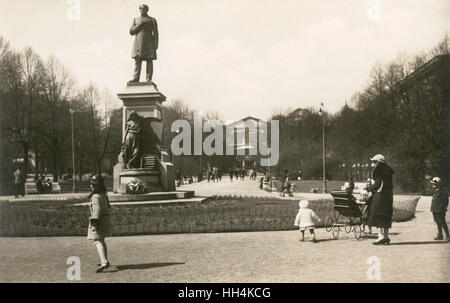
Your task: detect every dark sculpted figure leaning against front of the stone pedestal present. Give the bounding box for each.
[122,111,143,168]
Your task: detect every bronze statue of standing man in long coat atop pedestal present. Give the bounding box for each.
[130,4,159,82]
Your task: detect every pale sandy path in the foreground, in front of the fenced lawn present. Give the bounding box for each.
[0,197,450,283]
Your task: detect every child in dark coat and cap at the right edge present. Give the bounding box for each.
[430,177,450,241]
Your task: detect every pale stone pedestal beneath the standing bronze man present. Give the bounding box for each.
[113,82,175,194]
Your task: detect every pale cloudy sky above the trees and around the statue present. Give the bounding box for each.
[0,0,450,120]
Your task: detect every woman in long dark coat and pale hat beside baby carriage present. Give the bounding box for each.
[367,155,394,245]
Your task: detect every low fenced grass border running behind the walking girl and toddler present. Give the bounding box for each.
[0,196,420,237]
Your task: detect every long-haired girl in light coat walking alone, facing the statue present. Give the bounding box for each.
[87,175,112,273]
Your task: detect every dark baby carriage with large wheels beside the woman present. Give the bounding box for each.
[325,190,366,240]
